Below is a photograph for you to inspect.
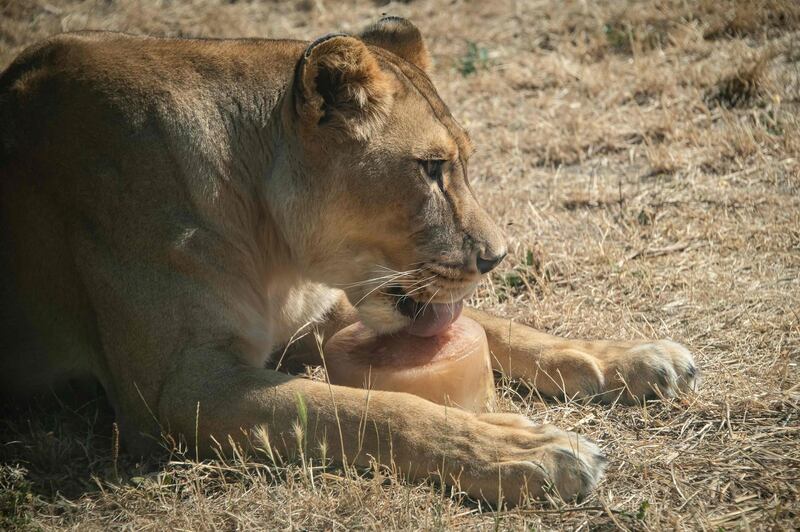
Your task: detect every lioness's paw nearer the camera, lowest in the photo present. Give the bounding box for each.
[468,414,606,504]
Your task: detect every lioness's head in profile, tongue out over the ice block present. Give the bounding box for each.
[277,17,506,335]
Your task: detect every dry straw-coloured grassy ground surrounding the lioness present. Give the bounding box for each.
[0,0,800,530]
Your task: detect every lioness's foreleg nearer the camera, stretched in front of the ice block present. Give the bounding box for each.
[158,353,604,503]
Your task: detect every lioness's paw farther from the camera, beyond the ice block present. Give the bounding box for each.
[600,340,699,404]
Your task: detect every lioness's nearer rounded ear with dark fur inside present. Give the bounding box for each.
[295,34,392,139]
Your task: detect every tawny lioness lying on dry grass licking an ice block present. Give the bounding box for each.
[0,17,695,503]
